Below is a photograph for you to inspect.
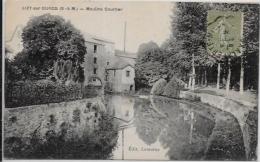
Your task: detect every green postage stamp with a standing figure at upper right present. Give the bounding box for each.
[207,10,243,56]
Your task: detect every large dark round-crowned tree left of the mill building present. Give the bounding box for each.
[21,14,86,82]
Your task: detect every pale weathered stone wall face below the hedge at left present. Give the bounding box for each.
[4,98,106,138]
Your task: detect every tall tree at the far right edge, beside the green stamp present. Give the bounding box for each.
[240,4,259,92]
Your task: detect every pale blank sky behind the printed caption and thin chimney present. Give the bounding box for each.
[5,0,174,52]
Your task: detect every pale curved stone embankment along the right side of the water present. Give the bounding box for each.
[180,87,258,159]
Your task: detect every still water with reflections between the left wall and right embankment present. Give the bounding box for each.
[107,95,256,160]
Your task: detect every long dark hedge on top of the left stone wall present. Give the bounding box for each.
[5,80,82,108]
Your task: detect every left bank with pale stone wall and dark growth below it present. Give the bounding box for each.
[4,97,118,159]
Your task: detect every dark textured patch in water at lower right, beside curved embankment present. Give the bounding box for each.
[205,115,249,160]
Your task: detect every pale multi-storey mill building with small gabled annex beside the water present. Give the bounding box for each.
[83,34,135,92]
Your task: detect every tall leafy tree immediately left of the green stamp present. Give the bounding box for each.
[169,3,210,89]
